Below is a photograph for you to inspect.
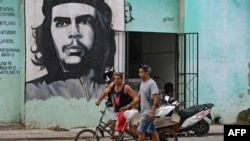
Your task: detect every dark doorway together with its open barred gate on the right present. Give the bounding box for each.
[125,32,198,107]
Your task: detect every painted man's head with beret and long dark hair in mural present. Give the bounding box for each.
[31,0,116,83]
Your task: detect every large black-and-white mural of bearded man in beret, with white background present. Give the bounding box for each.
[25,0,124,101]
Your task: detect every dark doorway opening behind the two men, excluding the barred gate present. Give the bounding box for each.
[125,32,177,93]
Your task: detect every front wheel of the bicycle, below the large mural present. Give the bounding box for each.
[75,129,99,141]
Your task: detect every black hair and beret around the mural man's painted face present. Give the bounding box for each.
[31,0,116,84]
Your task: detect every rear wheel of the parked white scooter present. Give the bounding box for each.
[193,119,210,137]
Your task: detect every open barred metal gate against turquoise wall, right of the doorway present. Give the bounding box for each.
[175,33,199,108]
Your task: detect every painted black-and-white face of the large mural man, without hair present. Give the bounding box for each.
[51,3,96,65]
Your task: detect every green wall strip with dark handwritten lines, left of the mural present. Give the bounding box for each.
[0,0,24,123]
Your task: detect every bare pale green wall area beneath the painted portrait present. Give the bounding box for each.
[25,97,103,128]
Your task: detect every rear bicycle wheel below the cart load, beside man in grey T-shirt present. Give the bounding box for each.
[157,128,178,141]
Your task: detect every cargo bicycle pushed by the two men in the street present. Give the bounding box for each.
[74,103,178,141]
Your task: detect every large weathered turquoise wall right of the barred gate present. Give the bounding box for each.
[184,0,250,123]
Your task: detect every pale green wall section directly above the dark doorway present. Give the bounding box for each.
[125,0,179,33]
